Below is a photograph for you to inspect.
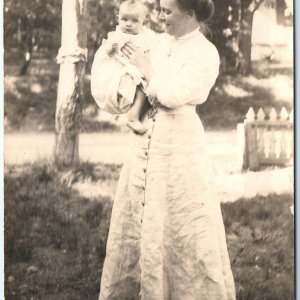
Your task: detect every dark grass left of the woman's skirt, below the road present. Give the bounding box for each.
[4,163,120,299]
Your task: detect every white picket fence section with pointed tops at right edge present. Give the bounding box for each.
[237,107,294,171]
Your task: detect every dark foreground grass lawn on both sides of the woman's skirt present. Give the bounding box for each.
[4,163,294,300]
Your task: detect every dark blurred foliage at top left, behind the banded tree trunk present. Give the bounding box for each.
[4,0,159,70]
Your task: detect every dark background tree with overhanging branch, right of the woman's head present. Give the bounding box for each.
[211,0,287,74]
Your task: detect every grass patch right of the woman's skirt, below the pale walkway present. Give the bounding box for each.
[222,195,294,300]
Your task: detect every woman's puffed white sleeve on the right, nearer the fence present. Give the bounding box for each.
[147,43,219,108]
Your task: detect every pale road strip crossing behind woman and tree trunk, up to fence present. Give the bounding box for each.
[4,131,239,168]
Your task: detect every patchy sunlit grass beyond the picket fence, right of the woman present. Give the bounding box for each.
[197,71,292,129]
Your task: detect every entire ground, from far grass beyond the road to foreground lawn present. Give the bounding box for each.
[4,55,294,300]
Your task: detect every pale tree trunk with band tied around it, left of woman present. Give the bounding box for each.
[54,0,87,167]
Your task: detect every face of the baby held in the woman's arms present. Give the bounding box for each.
[118,6,145,34]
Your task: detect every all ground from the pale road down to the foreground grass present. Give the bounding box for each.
[4,131,294,300]
